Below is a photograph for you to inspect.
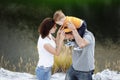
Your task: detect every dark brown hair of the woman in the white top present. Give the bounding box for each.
[38,18,55,38]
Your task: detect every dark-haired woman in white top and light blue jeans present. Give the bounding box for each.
[36,18,64,80]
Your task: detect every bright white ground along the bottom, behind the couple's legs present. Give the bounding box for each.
[0,68,120,80]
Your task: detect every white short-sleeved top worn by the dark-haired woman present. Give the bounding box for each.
[37,34,56,67]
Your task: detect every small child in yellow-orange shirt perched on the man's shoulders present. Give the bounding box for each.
[53,10,87,37]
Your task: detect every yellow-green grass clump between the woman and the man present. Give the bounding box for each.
[53,47,72,73]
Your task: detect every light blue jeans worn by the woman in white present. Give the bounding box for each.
[35,66,51,80]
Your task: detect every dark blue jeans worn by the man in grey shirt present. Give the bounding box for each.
[65,66,94,80]
